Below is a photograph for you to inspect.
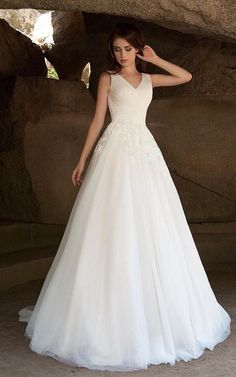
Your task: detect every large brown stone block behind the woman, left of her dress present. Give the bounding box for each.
[0,77,94,224]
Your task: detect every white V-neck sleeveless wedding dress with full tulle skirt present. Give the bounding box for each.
[18,73,231,371]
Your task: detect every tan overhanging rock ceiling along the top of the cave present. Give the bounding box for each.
[0,0,236,41]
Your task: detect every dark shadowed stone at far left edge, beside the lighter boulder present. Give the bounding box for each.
[0,77,38,221]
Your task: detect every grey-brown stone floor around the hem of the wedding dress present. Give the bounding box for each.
[0,264,236,377]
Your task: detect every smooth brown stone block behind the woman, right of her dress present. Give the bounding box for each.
[147,95,236,222]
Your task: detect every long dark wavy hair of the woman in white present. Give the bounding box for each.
[105,22,146,73]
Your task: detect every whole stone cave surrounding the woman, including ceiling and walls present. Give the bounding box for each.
[0,0,236,377]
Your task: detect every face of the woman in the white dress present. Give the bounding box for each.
[113,38,138,66]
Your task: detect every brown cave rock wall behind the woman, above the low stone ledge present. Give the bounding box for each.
[0,8,236,224]
